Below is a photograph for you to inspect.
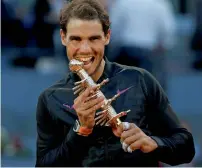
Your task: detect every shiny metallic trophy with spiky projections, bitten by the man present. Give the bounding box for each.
[69,59,130,137]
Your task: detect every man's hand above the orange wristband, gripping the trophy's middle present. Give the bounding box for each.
[74,86,104,129]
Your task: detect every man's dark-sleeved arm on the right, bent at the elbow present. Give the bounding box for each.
[142,71,195,165]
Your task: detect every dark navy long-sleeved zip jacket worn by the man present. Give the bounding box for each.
[36,60,195,167]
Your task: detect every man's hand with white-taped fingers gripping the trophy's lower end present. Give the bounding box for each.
[119,123,158,153]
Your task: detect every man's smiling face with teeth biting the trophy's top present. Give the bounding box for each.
[60,19,110,75]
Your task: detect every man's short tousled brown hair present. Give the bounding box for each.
[60,0,110,35]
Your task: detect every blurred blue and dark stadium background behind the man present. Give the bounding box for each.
[1,0,202,167]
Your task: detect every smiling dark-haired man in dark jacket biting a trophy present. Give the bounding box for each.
[36,0,195,167]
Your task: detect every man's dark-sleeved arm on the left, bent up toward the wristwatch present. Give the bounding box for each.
[36,94,90,167]
